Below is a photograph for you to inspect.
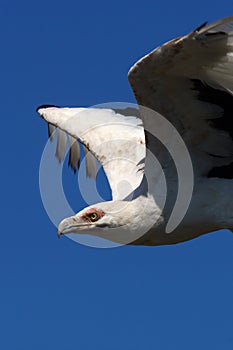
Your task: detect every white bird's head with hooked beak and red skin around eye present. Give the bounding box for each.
[58,201,151,243]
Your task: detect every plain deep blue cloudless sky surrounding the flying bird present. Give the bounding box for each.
[0,0,233,350]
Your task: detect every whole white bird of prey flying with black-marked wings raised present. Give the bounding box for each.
[37,16,233,245]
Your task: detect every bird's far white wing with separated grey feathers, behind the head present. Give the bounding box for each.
[37,105,145,200]
